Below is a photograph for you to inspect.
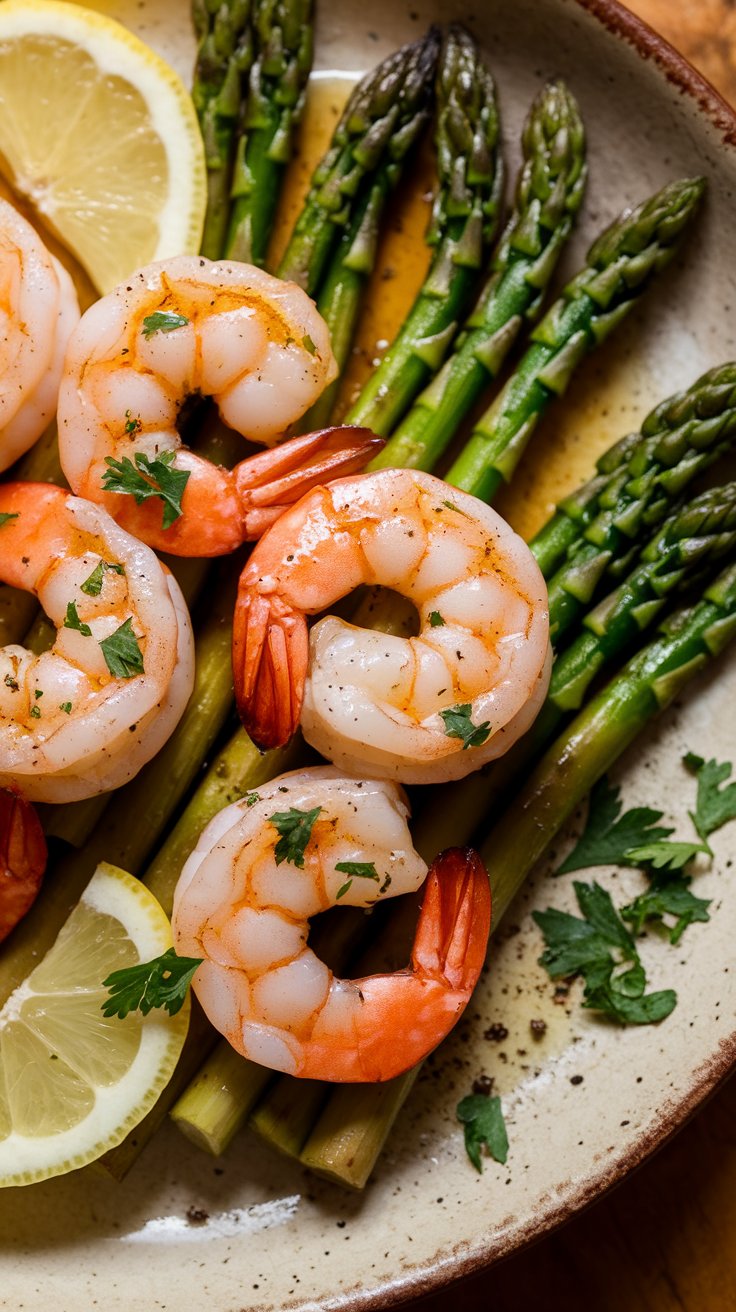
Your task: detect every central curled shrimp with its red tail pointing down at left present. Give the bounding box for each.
[234,470,550,783]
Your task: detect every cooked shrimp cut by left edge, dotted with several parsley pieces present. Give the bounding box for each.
[0,483,194,802]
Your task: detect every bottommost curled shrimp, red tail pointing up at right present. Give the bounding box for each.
[172,766,491,1081]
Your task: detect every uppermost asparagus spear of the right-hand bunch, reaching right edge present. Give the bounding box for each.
[530,362,736,579]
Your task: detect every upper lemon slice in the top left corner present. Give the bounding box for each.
[0,0,206,293]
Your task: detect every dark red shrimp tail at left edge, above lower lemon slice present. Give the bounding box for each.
[0,789,47,942]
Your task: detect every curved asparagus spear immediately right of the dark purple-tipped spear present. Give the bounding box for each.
[346,25,502,434]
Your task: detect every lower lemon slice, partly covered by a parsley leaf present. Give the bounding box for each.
[0,865,189,1186]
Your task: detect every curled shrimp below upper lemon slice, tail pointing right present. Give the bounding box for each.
[59,256,383,556]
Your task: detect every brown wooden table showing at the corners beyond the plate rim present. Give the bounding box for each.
[409,0,736,1312]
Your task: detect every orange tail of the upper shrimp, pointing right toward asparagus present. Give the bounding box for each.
[234,425,384,542]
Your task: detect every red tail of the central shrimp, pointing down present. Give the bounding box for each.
[232,586,308,752]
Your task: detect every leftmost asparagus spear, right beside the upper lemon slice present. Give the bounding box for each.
[192,0,253,260]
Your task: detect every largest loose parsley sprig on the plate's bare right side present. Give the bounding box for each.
[531,880,677,1025]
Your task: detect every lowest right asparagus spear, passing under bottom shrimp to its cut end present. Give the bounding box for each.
[300,565,736,1189]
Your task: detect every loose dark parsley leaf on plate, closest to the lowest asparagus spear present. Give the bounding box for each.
[555,775,672,875]
